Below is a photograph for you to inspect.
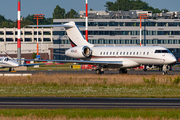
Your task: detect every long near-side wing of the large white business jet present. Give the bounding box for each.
[17,59,123,65]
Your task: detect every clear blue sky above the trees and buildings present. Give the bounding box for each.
[0,0,180,20]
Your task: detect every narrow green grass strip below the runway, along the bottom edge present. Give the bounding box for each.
[0,109,180,120]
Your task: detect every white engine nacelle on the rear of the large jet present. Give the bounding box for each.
[65,46,92,58]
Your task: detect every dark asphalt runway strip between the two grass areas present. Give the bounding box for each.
[0,97,180,109]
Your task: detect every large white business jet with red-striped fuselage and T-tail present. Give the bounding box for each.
[29,21,176,74]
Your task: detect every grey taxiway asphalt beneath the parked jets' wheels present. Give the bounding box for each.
[0,67,180,75]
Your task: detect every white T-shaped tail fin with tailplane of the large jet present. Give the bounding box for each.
[28,21,94,47]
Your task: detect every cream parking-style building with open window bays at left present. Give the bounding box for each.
[0,28,53,59]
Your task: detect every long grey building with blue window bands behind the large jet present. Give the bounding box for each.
[53,10,180,59]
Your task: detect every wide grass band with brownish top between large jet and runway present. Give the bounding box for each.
[0,74,180,98]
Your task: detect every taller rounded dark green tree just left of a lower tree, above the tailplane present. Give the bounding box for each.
[53,5,65,19]
